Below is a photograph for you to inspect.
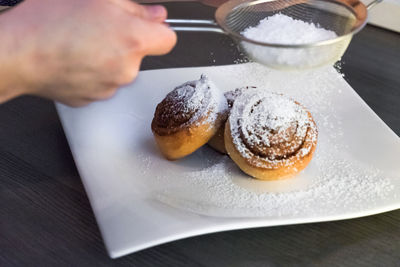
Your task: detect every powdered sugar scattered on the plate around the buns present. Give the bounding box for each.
[140,63,399,219]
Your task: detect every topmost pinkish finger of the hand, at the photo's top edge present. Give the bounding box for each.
[109,0,167,22]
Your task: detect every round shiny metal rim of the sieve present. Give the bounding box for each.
[215,0,368,48]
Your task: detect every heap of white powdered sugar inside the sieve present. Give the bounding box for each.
[241,14,339,67]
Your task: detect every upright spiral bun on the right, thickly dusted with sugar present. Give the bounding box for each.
[224,90,318,180]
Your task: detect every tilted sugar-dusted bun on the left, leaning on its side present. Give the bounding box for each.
[151,75,227,160]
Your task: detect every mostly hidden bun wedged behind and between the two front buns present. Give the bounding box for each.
[208,86,256,154]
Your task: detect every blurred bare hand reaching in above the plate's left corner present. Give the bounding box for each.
[0,0,176,106]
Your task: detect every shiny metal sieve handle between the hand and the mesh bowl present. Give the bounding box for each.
[165,19,225,34]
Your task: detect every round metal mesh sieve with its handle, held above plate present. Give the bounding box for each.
[166,0,382,70]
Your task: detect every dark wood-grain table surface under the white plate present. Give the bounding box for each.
[0,4,400,266]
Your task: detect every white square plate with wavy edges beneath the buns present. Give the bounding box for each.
[57,63,400,258]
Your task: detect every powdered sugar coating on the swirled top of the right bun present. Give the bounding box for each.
[229,88,317,167]
